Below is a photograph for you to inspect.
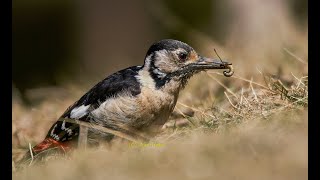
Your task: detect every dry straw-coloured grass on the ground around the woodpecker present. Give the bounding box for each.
[13,61,308,179]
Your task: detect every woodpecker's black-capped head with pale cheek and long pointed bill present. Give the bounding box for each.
[143,39,231,87]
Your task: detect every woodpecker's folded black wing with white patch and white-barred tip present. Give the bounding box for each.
[43,66,141,142]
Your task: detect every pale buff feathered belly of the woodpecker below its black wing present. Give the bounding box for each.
[92,87,178,129]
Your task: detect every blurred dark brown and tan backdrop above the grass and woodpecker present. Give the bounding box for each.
[12,0,308,103]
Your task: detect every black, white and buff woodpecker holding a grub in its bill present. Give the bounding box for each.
[21,39,233,160]
